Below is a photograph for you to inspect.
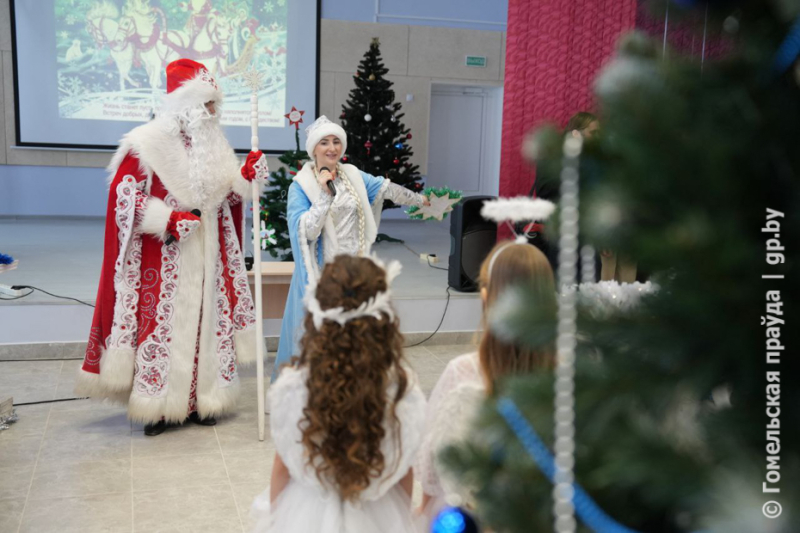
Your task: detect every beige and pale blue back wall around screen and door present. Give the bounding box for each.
[0,0,507,216]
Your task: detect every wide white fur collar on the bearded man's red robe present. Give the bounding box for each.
[108,117,238,210]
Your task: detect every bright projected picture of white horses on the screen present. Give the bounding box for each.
[56,0,287,126]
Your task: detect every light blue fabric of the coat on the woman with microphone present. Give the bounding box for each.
[271,171,386,381]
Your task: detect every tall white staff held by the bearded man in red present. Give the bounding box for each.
[243,68,266,440]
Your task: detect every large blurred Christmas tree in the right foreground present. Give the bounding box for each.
[443,0,800,533]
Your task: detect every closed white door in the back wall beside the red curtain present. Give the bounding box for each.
[426,85,502,196]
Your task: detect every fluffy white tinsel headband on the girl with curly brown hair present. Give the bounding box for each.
[303,255,402,329]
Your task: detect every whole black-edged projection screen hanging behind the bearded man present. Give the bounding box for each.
[11,0,319,153]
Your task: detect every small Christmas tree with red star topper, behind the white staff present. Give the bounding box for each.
[259,107,308,261]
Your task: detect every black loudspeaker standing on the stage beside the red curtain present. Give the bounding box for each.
[447,196,497,292]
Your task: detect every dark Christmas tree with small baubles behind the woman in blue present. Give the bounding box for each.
[339,38,422,207]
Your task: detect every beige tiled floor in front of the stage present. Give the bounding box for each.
[0,345,473,533]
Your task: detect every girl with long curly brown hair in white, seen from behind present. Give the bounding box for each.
[253,255,425,533]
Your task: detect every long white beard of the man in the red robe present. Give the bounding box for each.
[170,106,239,211]
